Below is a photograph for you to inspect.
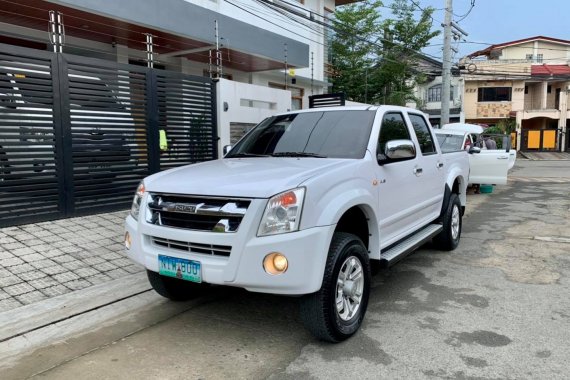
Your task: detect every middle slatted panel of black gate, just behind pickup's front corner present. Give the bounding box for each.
[63,55,149,215]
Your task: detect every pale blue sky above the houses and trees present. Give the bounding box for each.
[380,0,570,61]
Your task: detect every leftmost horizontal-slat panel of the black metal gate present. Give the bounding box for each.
[0,44,64,226]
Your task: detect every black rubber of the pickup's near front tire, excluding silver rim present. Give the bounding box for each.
[300,232,370,343]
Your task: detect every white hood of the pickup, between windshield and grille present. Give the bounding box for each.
[145,157,357,198]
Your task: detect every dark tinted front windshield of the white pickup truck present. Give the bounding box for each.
[226,110,376,158]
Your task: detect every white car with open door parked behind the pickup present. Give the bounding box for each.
[435,123,516,185]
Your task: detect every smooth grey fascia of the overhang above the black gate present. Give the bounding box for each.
[48,0,309,67]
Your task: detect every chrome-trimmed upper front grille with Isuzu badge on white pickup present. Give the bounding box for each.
[147,193,250,233]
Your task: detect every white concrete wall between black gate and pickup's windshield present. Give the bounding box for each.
[217,79,291,155]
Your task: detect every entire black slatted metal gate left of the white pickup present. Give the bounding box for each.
[0,44,217,227]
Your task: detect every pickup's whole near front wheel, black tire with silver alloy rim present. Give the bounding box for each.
[300,232,370,343]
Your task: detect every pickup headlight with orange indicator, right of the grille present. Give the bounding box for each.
[257,187,305,236]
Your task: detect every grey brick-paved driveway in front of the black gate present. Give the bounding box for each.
[0,211,143,312]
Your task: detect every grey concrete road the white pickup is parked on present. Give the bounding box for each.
[5,161,570,379]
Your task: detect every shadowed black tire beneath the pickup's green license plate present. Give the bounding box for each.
[146,270,209,302]
